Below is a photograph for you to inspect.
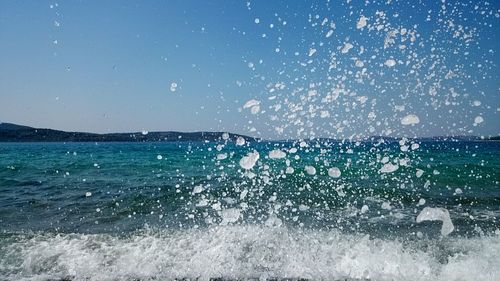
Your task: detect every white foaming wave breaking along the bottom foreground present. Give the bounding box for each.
[0,225,500,280]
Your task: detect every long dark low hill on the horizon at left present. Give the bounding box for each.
[0,123,257,142]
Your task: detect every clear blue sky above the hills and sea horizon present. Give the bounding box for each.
[0,0,500,138]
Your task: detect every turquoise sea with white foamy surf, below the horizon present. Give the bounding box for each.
[0,139,500,280]
